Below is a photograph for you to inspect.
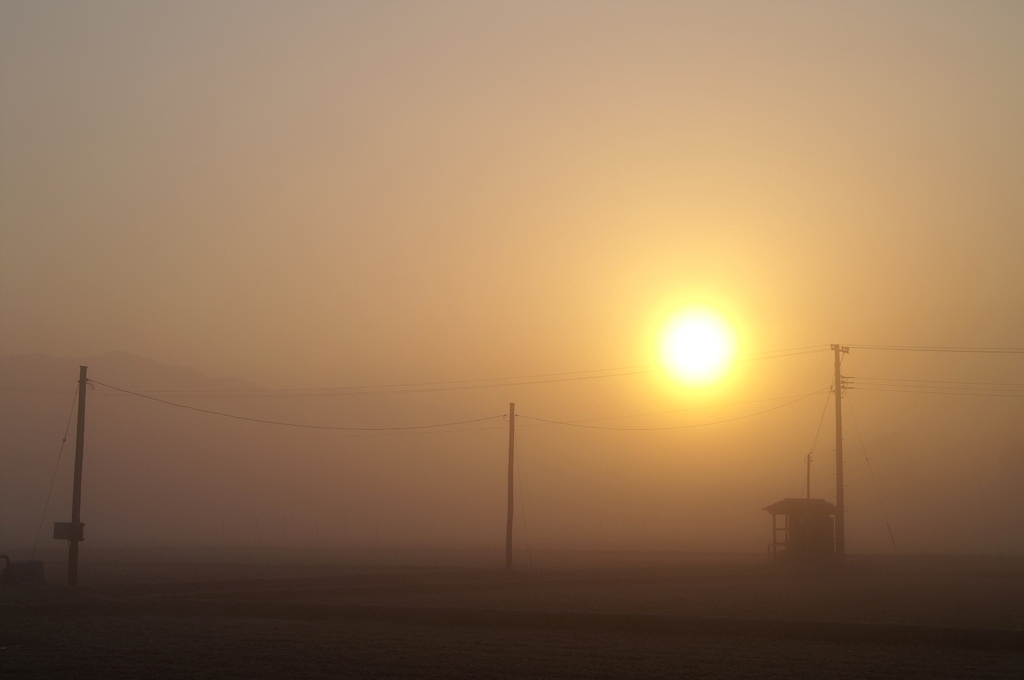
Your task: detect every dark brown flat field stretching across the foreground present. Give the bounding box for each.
[0,557,1024,679]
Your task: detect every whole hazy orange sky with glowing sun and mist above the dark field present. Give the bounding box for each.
[0,2,1024,554]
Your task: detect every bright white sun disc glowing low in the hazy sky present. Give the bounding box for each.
[660,309,735,385]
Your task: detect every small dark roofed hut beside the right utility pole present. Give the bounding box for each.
[765,498,836,559]
